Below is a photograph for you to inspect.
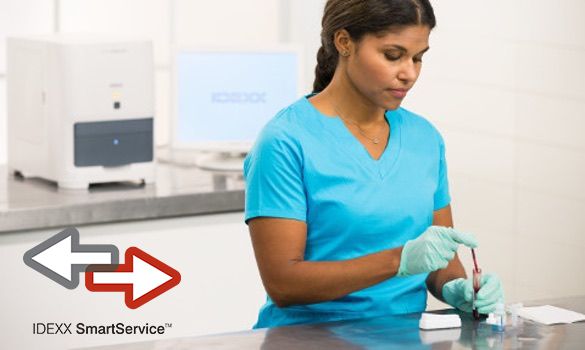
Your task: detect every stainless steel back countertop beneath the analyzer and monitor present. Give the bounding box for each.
[0,164,244,234]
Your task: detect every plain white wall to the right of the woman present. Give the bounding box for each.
[405,0,585,306]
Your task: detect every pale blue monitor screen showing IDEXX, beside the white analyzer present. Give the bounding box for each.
[173,49,300,148]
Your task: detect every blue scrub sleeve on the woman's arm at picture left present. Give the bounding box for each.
[244,124,307,224]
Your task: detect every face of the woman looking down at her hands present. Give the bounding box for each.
[346,25,430,110]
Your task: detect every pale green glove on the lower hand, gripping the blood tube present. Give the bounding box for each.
[443,274,504,314]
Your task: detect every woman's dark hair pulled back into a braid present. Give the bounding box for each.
[313,0,436,93]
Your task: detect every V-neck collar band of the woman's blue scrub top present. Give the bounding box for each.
[304,95,402,180]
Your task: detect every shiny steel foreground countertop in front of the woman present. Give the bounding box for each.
[81,296,585,350]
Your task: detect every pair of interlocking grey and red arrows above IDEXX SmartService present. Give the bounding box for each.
[23,227,181,309]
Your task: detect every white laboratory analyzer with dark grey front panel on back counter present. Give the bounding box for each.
[6,35,155,189]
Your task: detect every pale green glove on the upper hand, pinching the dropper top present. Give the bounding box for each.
[397,226,477,277]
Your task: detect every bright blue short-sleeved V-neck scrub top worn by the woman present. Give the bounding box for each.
[244,97,450,328]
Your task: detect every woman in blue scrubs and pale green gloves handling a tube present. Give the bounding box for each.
[244,0,502,327]
